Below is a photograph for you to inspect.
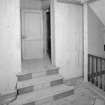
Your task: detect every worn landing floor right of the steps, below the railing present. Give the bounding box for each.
[43,84,105,105]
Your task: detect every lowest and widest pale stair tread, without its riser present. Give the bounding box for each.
[11,84,74,105]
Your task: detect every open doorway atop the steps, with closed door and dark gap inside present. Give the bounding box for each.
[21,0,53,72]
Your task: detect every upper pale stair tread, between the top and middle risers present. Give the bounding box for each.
[17,74,63,88]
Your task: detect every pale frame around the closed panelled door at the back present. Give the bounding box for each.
[21,9,44,60]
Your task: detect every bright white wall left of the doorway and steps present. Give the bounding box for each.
[0,0,20,93]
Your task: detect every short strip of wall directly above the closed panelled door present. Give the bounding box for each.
[20,0,42,10]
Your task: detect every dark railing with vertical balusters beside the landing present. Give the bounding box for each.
[88,54,105,90]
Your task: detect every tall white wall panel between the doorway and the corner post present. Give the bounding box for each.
[54,0,82,79]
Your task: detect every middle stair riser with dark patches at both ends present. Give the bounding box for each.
[18,79,63,94]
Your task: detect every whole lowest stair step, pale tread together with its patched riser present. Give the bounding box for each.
[10,84,74,105]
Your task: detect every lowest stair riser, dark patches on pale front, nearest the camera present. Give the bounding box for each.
[22,90,74,105]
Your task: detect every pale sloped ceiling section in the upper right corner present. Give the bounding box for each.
[89,0,105,25]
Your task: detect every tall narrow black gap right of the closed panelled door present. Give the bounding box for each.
[46,10,51,60]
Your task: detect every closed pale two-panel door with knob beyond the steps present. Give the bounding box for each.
[22,10,43,59]
